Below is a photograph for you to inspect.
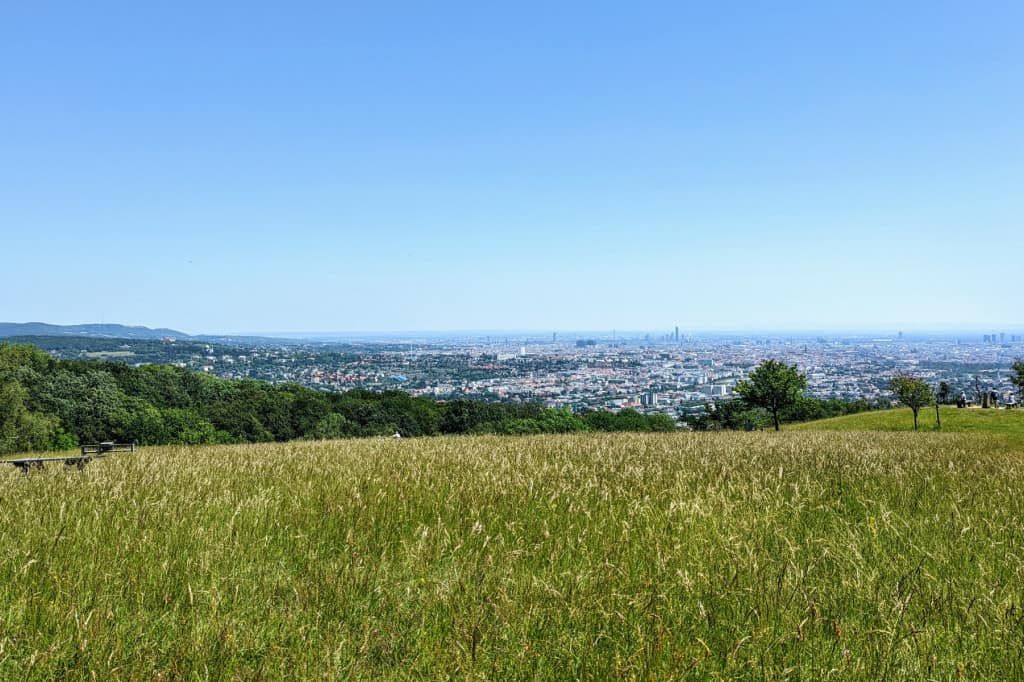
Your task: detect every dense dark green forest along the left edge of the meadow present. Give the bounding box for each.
[0,344,676,453]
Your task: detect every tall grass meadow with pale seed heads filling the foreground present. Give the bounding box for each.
[0,432,1024,680]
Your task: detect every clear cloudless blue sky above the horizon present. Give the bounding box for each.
[0,0,1024,333]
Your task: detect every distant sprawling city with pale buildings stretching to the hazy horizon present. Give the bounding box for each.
[10,327,1024,419]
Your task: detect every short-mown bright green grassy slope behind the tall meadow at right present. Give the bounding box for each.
[786,406,1024,441]
